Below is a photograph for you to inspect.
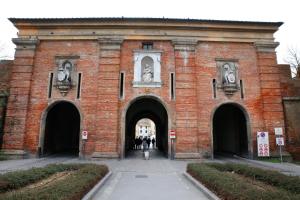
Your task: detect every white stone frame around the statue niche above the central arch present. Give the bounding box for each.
[132,50,162,87]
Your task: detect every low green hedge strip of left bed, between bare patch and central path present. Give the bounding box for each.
[0,164,108,200]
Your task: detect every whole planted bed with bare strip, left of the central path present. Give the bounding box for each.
[0,164,108,200]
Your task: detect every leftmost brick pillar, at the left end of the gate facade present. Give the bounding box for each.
[3,38,39,156]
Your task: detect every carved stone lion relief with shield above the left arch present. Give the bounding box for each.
[54,56,79,96]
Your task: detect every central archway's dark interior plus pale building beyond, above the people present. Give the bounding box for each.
[125,97,168,157]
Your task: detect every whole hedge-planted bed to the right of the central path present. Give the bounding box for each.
[187,163,300,200]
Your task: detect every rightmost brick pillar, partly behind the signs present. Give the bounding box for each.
[254,43,284,155]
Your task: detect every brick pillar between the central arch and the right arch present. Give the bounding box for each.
[173,40,200,158]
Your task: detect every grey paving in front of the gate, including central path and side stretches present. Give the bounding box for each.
[0,151,300,200]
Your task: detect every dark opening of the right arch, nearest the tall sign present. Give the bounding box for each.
[213,104,249,157]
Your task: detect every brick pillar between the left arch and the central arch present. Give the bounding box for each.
[92,38,123,158]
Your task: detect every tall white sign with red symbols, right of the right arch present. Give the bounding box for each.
[257,132,270,157]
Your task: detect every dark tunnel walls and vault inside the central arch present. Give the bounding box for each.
[125,98,168,157]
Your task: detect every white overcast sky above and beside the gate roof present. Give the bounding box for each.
[0,0,300,63]
